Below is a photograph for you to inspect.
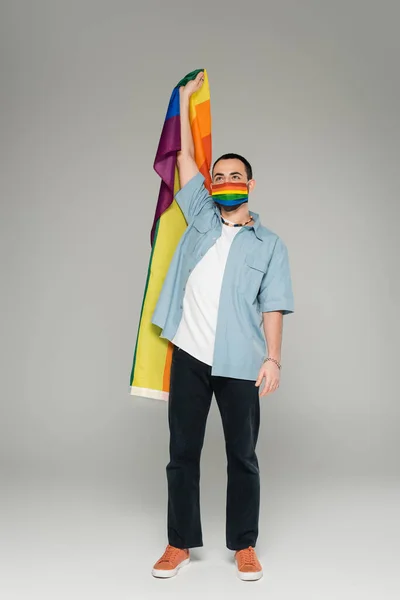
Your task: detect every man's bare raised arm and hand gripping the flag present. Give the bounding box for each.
[177,71,204,188]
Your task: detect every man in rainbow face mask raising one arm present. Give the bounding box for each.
[152,73,294,580]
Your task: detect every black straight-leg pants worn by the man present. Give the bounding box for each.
[166,346,260,550]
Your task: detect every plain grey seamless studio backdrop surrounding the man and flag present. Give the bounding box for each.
[0,0,400,600]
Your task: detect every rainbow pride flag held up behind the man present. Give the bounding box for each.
[130,69,211,400]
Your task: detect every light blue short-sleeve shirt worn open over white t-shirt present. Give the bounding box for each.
[152,173,294,381]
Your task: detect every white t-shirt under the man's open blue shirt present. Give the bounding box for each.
[172,219,240,365]
